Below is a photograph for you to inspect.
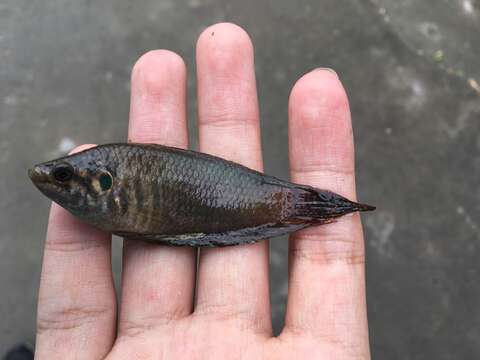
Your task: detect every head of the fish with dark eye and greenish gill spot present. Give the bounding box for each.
[28,148,116,218]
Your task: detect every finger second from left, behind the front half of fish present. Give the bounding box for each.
[119,50,196,336]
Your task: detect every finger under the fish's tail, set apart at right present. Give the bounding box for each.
[284,70,368,354]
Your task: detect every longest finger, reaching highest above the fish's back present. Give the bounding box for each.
[195,23,271,332]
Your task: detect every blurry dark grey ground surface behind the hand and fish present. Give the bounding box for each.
[0,0,480,359]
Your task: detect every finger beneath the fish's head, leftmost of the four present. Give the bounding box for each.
[35,146,116,359]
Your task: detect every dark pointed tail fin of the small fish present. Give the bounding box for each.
[293,186,376,222]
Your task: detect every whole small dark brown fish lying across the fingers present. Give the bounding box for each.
[28,143,375,247]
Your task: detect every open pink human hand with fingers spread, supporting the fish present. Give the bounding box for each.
[35,23,370,359]
